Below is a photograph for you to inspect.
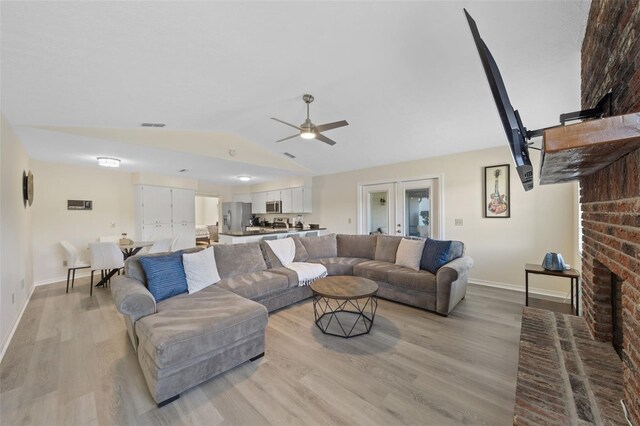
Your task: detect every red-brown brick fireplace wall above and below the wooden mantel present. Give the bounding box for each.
[580,0,640,425]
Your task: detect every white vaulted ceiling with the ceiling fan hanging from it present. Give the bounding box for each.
[0,1,589,184]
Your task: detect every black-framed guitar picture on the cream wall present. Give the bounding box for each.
[482,164,511,218]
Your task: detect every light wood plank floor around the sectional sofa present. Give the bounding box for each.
[0,280,523,425]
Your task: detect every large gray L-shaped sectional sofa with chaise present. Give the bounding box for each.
[111,234,473,405]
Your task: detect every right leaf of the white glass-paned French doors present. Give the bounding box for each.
[396,179,440,238]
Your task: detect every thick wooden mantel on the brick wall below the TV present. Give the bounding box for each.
[540,113,640,185]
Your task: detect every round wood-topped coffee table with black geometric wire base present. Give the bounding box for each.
[311,275,378,338]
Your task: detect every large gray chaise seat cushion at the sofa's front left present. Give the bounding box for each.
[135,285,267,368]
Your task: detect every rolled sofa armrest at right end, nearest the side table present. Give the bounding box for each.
[436,256,473,315]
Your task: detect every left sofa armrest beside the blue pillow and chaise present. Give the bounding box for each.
[111,276,156,323]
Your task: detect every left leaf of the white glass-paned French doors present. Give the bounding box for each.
[361,183,395,234]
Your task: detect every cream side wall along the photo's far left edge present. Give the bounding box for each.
[0,115,33,359]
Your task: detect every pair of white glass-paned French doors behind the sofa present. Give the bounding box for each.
[360,179,440,238]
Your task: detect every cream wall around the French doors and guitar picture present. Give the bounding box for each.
[307,147,576,293]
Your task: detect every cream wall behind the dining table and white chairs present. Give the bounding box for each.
[32,161,134,284]
